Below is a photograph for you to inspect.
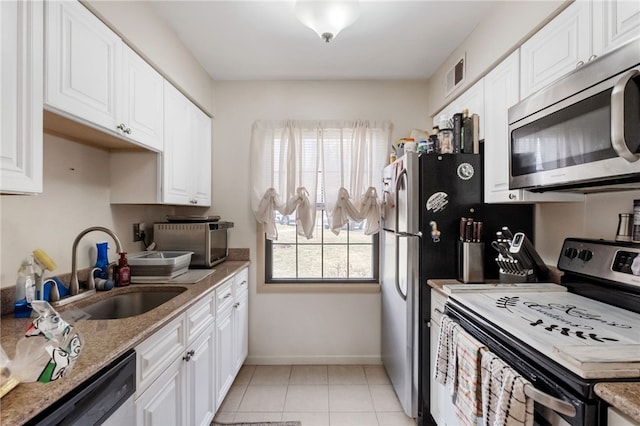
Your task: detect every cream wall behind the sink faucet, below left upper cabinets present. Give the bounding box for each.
[0,134,178,287]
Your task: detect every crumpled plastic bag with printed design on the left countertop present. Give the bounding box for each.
[13,300,83,383]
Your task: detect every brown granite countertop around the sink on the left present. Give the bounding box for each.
[0,261,249,425]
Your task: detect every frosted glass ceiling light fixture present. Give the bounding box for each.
[295,0,360,43]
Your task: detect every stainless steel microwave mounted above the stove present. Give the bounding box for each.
[509,40,640,192]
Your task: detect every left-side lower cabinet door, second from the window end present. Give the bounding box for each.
[216,309,235,406]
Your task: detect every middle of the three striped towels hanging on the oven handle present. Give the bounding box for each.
[455,329,487,426]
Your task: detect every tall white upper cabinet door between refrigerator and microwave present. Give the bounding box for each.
[484,51,520,203]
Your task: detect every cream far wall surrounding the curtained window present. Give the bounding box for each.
[212,81,427,363]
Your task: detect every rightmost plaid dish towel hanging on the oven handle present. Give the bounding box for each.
[481,350,533,426]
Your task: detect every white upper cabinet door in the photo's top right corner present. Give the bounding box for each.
[593,0,640,55]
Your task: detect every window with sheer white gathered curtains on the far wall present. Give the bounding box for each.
[251,120,391,283]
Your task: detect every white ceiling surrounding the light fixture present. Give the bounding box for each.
[149,0,498,80]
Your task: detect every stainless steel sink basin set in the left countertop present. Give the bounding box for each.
[82,288,186,320]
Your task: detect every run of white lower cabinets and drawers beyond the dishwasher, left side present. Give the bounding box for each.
[135,268,249,426]
